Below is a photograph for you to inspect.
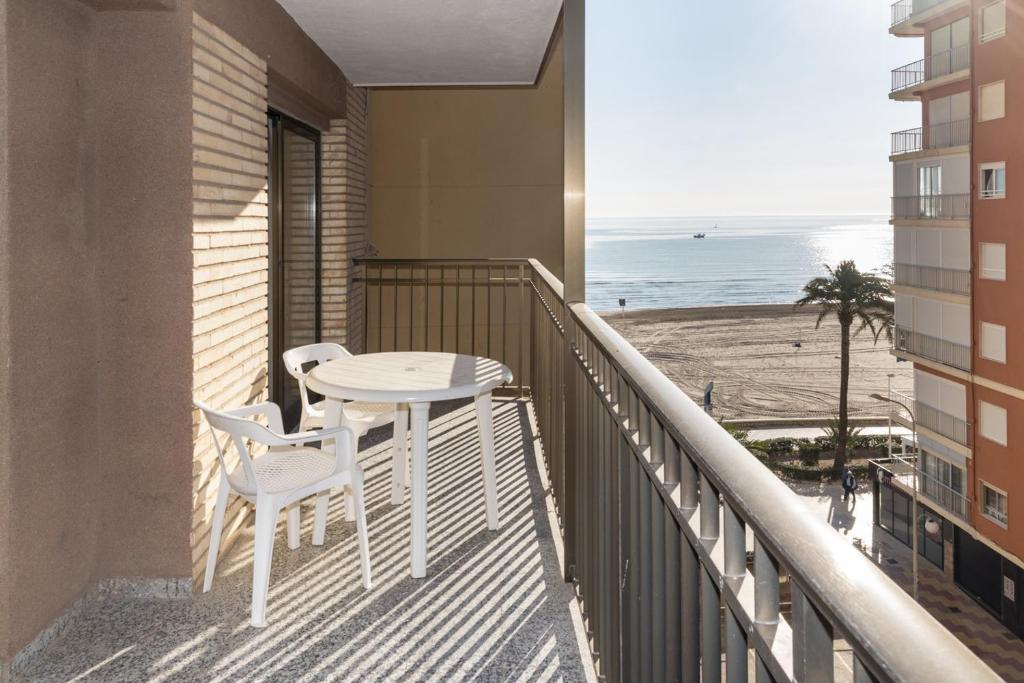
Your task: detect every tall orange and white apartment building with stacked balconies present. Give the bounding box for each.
[876,0,1024,634]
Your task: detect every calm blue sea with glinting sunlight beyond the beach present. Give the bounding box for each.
[587,215,893,310]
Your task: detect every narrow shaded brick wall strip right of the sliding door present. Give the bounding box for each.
[321,84,369,353]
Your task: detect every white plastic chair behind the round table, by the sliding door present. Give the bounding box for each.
[282,342,409,505]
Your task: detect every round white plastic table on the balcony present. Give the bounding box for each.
[306,351,512,579]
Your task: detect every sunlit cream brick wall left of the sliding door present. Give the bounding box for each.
[190,14,268,578]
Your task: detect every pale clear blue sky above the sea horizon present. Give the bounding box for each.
[586,0,924,217]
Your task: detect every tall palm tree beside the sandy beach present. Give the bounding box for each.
[796,261,893,472]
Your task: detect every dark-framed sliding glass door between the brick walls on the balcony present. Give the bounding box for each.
[267,112,321,427]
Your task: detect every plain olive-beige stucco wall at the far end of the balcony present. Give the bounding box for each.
[370,29,563,276]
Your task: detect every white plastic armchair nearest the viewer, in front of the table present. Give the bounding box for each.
[193,400,372,627]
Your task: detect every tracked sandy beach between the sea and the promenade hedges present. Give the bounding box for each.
[602,304,913,420]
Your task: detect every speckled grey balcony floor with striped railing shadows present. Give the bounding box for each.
[24,399,590,681]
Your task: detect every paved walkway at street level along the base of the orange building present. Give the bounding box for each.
[786,481,1024,683]
